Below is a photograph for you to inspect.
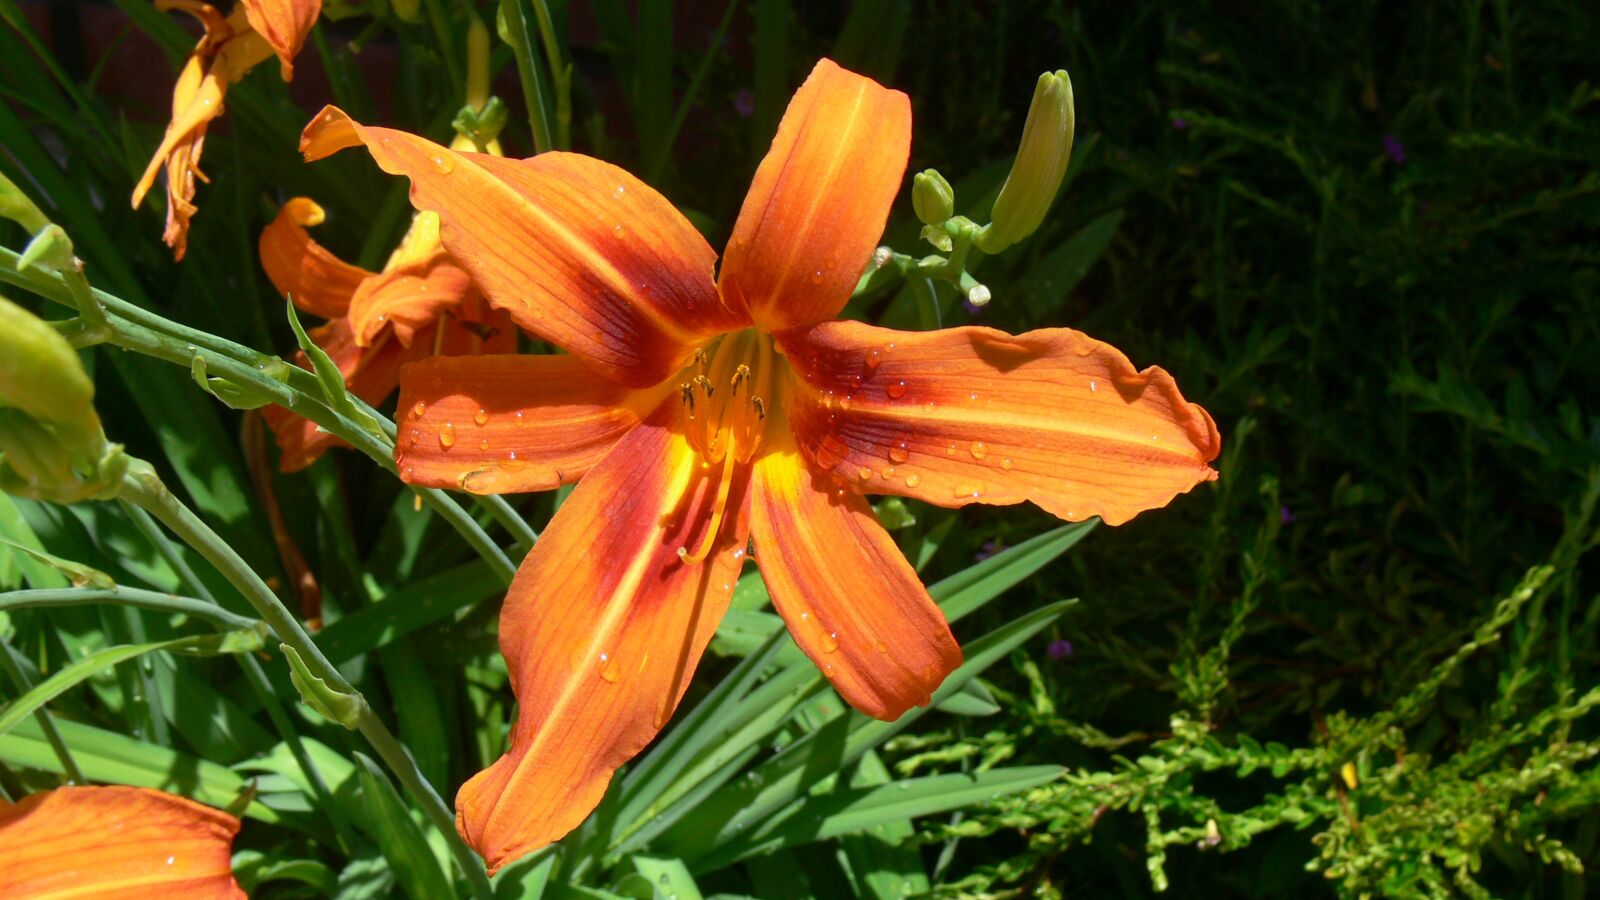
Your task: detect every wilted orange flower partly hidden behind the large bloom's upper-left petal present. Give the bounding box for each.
[261,197,517,472]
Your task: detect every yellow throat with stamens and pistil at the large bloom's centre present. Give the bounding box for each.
[678,328,774,564]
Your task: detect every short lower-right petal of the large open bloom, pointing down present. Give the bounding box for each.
[750,426,962,721]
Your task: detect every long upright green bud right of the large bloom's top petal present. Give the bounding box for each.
[978,70,1074,253]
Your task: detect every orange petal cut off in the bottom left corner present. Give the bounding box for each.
[0,786,245,900]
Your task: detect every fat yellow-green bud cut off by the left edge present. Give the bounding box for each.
[0,296,99,441]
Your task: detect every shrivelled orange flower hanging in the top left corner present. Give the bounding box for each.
[133,0,322,259]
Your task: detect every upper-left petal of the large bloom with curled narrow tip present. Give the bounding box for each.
[301,107,744,388]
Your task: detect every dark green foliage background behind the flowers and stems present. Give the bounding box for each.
[0,0,1600,897]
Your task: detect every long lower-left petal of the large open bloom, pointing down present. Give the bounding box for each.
[456,397,749,871]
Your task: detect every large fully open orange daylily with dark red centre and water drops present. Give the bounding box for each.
[301,59,1219,870]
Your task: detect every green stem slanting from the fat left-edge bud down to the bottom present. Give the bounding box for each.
[120,460,493,898]
